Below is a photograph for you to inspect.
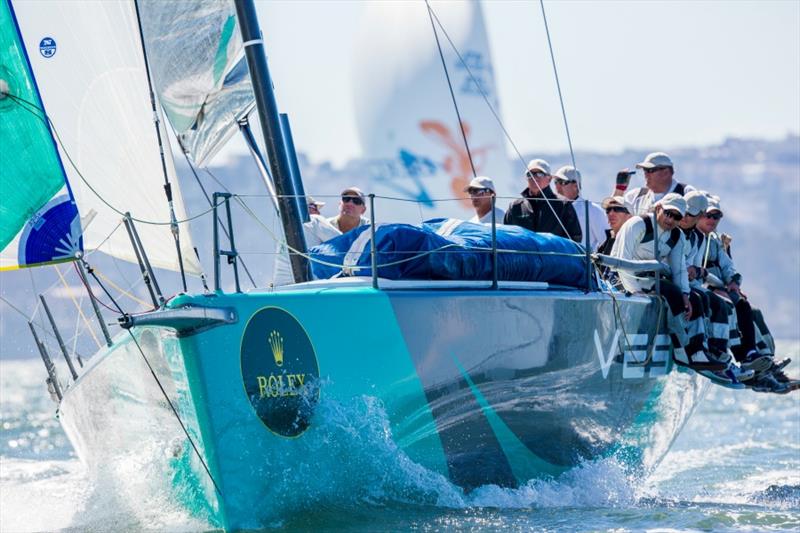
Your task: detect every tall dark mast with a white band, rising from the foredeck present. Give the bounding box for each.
[234,0,310,283]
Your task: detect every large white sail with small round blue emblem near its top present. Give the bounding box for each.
[13,0,201,274]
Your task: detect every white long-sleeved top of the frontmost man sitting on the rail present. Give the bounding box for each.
[611,214,689,294]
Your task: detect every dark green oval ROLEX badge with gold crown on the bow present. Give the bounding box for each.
[241,307,319,437]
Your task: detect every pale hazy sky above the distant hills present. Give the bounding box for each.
[239,0,800,163]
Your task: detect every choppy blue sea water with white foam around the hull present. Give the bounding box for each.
[0,342,800,532]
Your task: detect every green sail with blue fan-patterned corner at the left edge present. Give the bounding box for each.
[0,0,80,270]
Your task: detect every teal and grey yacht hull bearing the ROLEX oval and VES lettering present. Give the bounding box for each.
[60,286,704,529]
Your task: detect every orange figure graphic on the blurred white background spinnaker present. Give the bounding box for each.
[419,120,493,209]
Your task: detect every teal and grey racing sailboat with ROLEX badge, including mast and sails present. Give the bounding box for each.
[0,0,706,530]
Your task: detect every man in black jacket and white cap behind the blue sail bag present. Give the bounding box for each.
[503,159,583,242]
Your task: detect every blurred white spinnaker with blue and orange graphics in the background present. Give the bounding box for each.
[353,1,510,217]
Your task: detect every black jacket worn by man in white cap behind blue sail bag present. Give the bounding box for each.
[503,187,582,242]
